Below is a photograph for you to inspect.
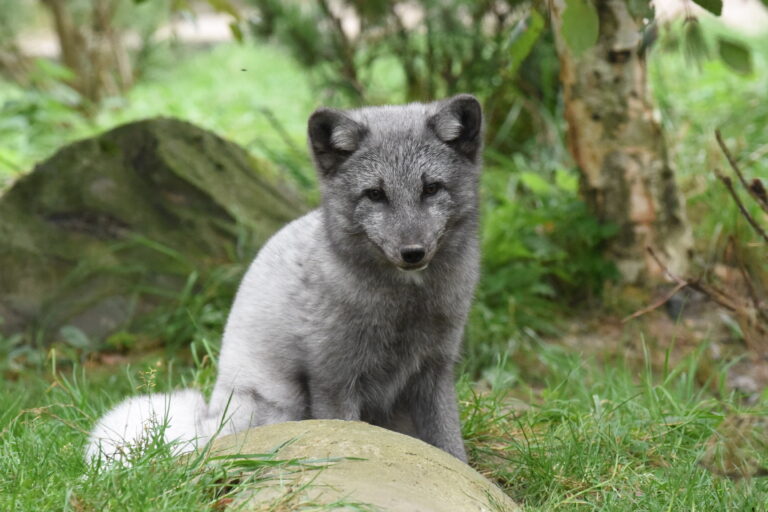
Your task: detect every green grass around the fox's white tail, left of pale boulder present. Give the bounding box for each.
[0,362,367,511]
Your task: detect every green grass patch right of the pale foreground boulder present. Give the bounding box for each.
[464,347,768,511]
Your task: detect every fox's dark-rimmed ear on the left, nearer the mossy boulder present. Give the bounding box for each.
[308,107,366,176]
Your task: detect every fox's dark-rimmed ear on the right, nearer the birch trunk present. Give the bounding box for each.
[428,94,483,161]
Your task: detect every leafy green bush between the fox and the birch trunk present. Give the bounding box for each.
[467,154,618,371]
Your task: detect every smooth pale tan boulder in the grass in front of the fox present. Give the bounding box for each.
[211,420,519,512]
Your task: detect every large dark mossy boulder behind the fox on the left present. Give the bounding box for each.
[0,118,305,339]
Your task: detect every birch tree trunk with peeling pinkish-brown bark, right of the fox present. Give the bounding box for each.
[550,0,692,283]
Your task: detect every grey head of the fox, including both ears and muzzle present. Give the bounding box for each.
[309,94,483,271]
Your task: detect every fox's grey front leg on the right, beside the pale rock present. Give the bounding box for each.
[408,363,467,462]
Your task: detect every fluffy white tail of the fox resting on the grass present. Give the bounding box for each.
[85,389,213,463]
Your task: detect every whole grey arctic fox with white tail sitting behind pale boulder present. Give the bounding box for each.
[86,95,482,461]
